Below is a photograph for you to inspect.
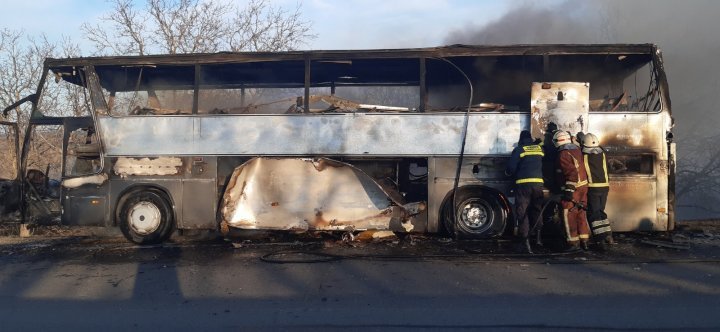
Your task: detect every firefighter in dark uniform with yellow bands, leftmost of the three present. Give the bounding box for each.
[505,130,544,253]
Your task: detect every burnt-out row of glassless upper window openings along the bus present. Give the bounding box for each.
[56,45,660,115]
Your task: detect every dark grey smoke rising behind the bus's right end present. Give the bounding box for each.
[445,0,720,219]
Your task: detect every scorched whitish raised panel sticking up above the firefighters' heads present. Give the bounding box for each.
[530,82,590,139]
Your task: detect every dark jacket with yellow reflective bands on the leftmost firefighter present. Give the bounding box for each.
[505,138,545,185]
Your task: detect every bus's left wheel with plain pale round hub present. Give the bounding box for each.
[117,189,175,244]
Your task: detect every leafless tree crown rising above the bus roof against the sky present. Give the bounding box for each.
[82,0,315,55]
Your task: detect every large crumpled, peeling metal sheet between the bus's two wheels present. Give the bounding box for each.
[221,158,425,231]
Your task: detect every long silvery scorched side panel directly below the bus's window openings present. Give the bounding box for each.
[99,113,529,157]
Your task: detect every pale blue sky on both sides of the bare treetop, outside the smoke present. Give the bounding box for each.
[0,0,517,52]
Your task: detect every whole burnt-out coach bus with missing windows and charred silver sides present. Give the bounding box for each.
[1,44,675,243]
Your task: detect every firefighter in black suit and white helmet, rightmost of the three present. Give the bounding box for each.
[578,133,614,248]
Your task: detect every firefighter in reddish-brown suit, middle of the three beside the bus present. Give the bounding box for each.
[553,131,590,250]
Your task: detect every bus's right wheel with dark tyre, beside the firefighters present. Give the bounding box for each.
[442,188,508,239]
